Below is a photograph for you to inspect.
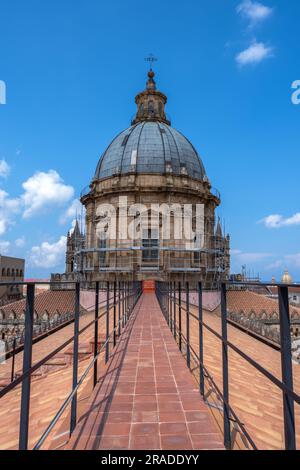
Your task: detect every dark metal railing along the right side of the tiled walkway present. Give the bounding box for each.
[156,282,300,450]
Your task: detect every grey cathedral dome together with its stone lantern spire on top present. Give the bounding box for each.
[95,69,206,180]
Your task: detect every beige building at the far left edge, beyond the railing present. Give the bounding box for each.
[0,255,25,305]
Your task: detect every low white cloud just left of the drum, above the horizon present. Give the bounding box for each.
[29,236,67,268]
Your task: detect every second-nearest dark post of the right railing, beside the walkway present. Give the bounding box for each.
[221,283,231,450]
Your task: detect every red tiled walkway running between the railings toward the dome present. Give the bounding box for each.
[66,293,223,450]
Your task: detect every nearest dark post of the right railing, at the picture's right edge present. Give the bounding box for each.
[278,286,296,450]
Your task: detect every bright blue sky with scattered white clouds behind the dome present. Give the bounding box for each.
[0,0,300,280]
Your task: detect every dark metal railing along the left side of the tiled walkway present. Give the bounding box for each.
[0,281,142,450]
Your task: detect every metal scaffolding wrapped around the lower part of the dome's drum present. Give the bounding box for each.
[67,222,229,288]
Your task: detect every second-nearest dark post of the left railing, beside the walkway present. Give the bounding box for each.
[70,282,80,434]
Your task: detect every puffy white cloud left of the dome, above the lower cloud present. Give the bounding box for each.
[22,170,74,219]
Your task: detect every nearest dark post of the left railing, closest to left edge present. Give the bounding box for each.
[19,284,35,450]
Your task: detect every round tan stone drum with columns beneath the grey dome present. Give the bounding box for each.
[82,174,229,284]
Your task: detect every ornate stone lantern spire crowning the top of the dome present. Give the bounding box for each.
[132,66,171,125]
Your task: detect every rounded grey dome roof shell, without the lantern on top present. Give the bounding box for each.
[95,121,205,180]
